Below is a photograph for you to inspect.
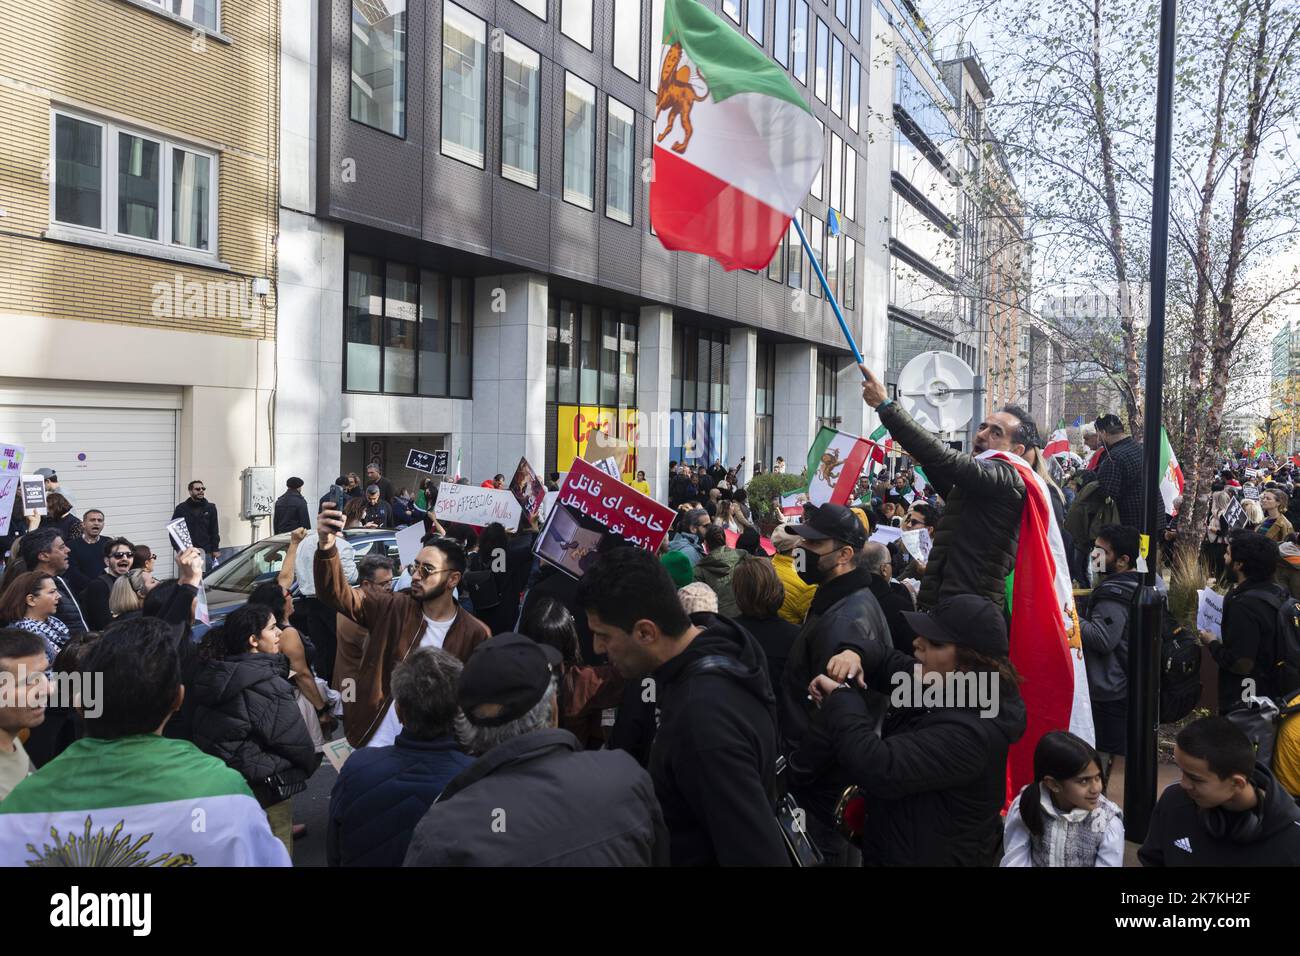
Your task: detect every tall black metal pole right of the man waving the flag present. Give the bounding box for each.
[1125,0,1178,840]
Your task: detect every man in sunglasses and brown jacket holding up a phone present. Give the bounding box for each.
[312,507,491,747]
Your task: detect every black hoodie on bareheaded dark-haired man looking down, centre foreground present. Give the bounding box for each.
[650,618,789,866]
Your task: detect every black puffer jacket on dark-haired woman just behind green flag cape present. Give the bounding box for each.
[192,654,320,801]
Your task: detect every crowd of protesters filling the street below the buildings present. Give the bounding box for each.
[0,377,1300,866]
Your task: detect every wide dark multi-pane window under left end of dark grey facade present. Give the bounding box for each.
[343,252,471,398]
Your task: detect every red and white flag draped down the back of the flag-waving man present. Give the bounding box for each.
[979,449,1095,803]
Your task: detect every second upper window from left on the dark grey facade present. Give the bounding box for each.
[442,3,488,169]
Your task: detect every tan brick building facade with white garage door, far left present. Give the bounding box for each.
[0,0,280,571]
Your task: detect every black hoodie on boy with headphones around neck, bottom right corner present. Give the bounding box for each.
[1138,763,1300,866]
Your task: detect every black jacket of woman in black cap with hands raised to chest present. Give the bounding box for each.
[822,648,1026,866]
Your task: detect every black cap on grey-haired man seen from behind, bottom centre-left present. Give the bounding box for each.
[456,632,564,727]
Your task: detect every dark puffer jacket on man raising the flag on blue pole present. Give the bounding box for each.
[880,402,1024,610]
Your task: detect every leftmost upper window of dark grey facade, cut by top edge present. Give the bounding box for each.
[351,0,407,138]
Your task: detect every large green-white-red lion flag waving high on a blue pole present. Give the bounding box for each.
[650,0,822,269]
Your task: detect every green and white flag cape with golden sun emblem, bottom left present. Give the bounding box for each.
[0,734,293,866]
